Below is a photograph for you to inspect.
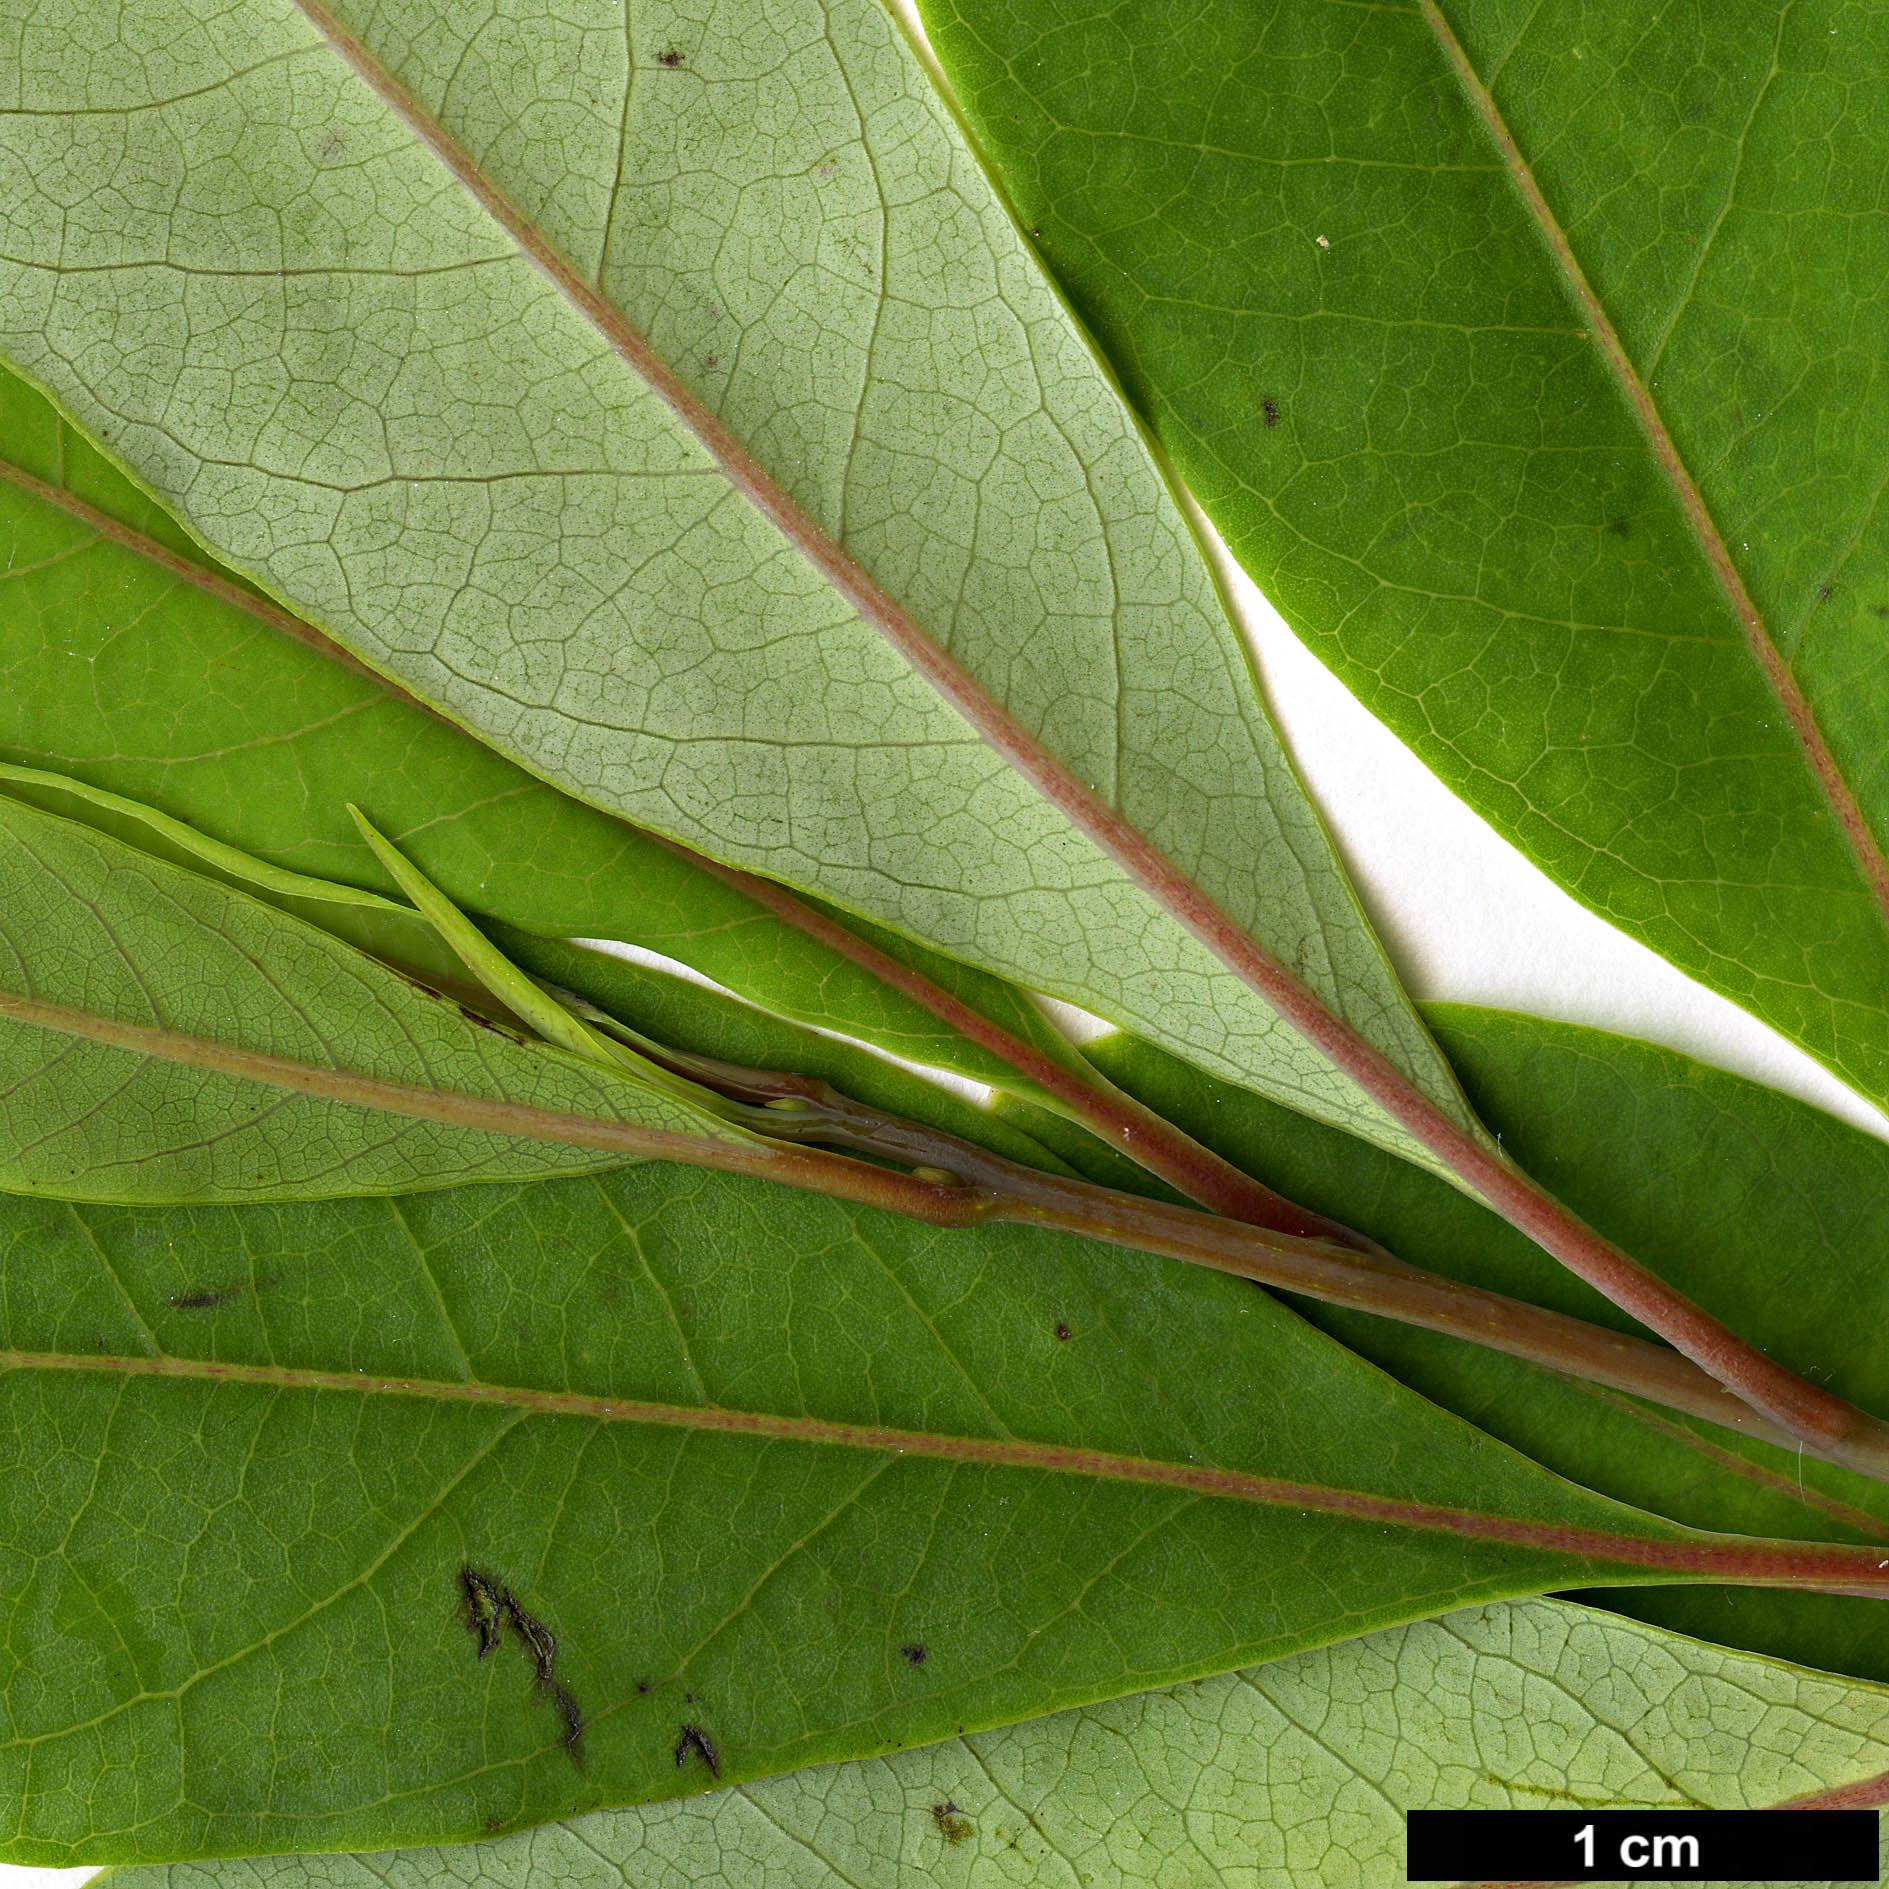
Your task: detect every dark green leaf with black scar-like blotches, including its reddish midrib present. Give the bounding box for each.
[0,1162,1790,1863]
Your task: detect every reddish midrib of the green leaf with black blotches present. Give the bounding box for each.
[11,1351,1889,1594]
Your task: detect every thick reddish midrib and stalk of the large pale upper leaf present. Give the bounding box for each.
[273,0,1889,1473]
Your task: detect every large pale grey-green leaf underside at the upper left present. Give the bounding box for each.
[0,0,1475,1160]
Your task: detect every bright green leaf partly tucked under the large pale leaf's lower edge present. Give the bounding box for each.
[0,355,1095,1110]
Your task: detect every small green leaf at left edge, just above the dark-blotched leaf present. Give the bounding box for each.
[0,795,752,1201]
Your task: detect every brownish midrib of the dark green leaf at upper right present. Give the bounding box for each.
[1417,0,1889,922]
